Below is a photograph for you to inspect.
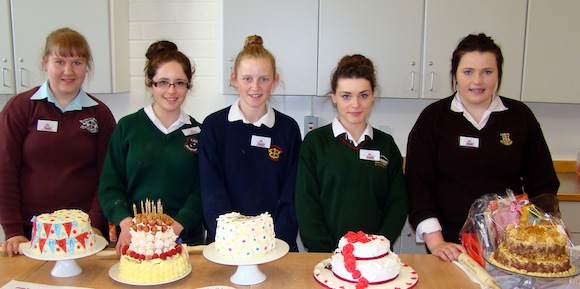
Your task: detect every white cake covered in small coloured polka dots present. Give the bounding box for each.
[214,212,276,258]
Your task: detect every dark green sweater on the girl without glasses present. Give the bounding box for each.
[296,125,408,252]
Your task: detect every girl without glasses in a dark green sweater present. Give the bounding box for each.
[296,55,408,252]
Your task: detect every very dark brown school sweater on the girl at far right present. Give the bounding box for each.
[405,96,559,243]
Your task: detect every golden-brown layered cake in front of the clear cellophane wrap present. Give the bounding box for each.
[491,223,575,277]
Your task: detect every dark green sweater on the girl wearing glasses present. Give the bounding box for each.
[99,109,202,237]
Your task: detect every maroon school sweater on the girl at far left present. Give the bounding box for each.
[0,87,115,239]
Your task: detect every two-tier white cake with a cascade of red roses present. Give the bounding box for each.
[330,231,402,284]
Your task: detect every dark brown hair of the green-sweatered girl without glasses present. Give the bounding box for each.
[330,54,377,93]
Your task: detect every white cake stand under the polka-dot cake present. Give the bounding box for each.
[203,239,290,285]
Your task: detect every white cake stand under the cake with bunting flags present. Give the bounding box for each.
[22,236,107,277]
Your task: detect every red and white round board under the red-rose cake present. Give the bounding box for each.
[313,258,419,289]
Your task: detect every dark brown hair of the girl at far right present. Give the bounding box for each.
[449,33,503,91]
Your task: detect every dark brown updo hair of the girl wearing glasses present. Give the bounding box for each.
[144,40,195,88]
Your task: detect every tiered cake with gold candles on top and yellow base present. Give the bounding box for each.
[119,200,191,284]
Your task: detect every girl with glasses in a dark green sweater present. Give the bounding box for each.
[99,41,204,255]
